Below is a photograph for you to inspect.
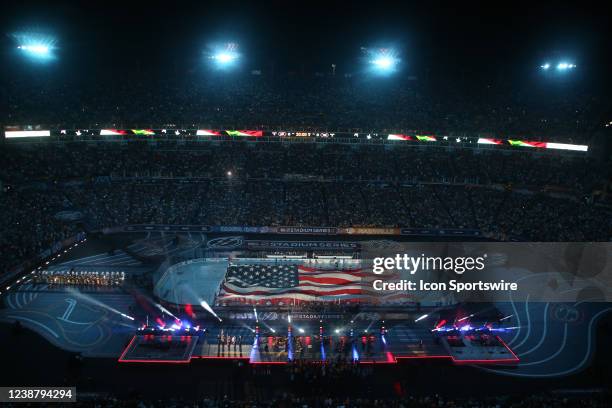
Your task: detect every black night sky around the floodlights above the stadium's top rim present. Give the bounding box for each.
[0,0,612,83]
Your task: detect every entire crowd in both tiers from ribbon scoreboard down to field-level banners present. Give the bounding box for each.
[0,142,612,276]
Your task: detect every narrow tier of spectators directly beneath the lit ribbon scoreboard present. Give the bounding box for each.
[0,142,610,192]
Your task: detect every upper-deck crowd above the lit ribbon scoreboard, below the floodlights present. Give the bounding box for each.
[5,74,610,141]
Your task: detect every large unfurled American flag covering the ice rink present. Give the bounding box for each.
[217,264,412,303]
